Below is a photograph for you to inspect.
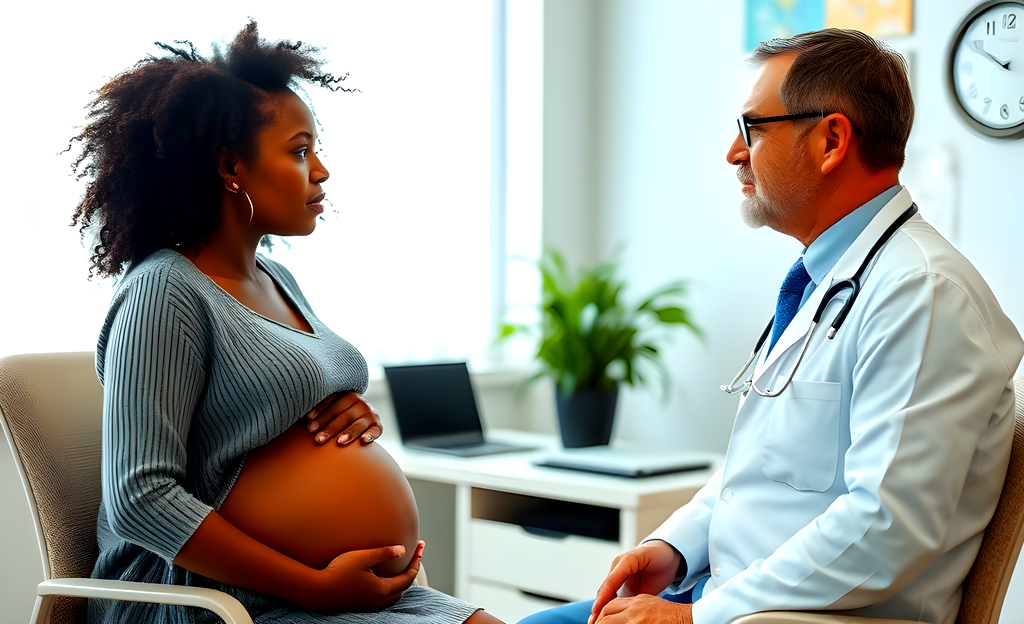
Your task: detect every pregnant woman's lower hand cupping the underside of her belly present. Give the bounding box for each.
[302,541,423,611]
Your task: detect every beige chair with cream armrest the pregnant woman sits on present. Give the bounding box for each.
[0,352,427,624]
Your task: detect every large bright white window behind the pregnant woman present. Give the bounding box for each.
[0,0,541,364]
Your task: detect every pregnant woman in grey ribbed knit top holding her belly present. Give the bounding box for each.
[75,23,497,624]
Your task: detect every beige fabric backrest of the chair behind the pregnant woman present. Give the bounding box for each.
[0,352,103,622]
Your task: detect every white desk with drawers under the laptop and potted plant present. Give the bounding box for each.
[381,430,722,622]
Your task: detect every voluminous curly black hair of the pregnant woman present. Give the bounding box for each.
[71,22,352,277]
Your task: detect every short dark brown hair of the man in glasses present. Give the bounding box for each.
[748,29,913,171]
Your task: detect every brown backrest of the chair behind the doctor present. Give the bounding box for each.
[956,376,1024,624]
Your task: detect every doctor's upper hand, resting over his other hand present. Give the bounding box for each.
[587,540,683,624]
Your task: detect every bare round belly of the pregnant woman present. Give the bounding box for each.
[219,420,419,576]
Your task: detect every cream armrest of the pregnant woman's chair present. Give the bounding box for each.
[32,579,253,624]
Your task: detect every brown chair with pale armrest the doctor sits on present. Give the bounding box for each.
[732,376,1024,624]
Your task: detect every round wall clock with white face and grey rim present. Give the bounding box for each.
[950,2,1024,136]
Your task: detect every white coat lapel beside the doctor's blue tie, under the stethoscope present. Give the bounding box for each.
[754,188,913,387]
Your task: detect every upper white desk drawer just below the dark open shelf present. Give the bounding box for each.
[469,519,623,600]
